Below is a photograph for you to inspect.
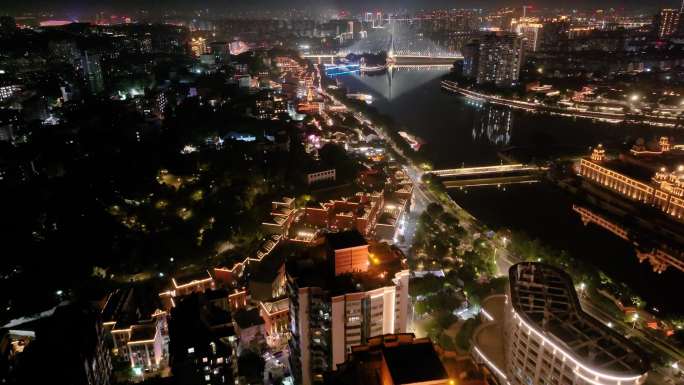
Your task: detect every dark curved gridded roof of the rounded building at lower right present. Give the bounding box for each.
[509,262,649,375]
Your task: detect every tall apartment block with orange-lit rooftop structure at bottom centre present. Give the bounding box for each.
[287,231,409,385]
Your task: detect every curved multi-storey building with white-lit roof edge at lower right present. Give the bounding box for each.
[473,262,649,385]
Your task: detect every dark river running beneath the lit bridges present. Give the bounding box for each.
[337,69,684,314]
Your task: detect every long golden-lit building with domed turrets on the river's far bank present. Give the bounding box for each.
[579,138,684,220]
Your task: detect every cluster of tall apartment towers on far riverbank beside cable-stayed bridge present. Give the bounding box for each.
[463,32,523,87]
